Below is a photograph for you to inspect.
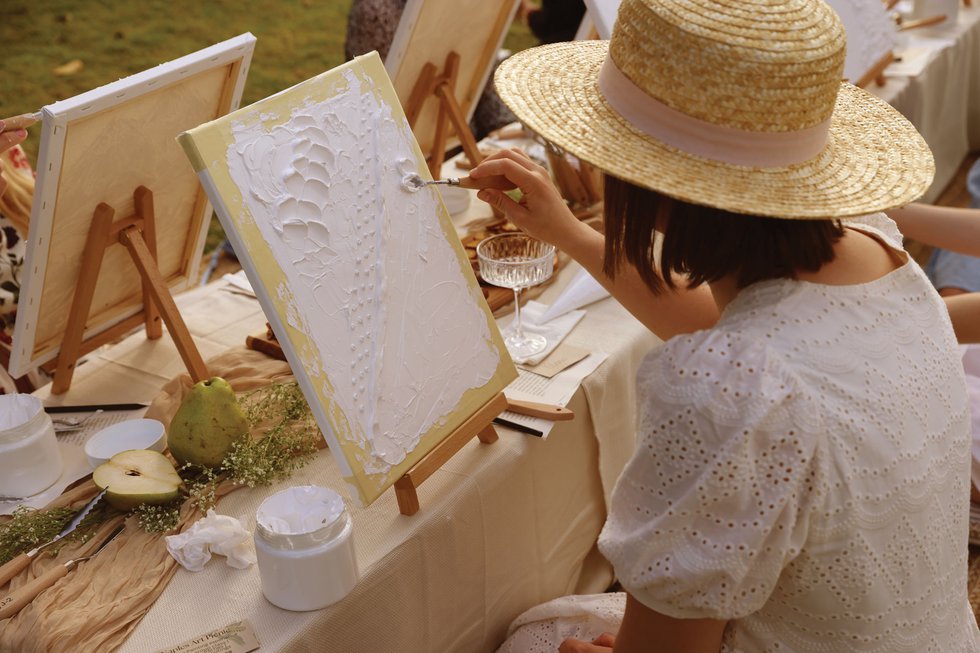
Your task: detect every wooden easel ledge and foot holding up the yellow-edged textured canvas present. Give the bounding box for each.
[395,392,507,515]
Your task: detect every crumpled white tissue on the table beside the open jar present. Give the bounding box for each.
[164,508,255,571]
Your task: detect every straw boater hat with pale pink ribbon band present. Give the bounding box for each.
[495,0,935,218]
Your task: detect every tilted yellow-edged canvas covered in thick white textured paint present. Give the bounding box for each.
[180,53,516,504]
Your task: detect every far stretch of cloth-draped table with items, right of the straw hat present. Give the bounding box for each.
[867,3,980,202]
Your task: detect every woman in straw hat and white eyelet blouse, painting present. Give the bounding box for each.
[471,0,980,653]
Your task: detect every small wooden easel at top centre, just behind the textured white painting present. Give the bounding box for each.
[405,52,484,179]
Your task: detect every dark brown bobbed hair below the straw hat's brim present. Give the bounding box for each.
[603,175,844,294]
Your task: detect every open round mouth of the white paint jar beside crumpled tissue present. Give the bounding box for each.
[255,485,344,535]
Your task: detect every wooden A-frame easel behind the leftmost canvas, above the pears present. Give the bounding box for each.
[51,186,209,394]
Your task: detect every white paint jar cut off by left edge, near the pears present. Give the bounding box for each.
[0,394,64,498]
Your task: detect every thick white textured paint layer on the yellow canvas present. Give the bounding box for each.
[227,70,499,474]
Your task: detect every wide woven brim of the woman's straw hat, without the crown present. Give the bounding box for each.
[494,41,935,219]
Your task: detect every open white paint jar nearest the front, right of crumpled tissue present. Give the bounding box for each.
[255,485,358,611]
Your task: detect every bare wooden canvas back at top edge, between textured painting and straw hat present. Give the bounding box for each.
[385,0,519,171]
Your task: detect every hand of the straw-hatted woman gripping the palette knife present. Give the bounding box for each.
[470,149,581,249]
